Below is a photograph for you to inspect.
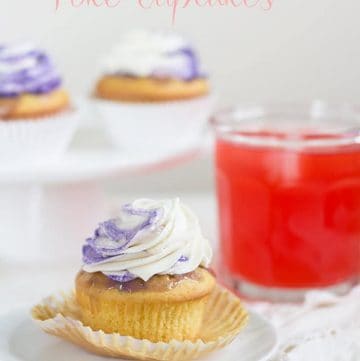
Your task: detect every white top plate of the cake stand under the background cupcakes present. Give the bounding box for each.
[0,143,202,184]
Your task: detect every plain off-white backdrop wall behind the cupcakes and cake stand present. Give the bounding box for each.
[0,0,360,189]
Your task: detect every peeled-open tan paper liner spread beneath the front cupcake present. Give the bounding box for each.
[32,286,248,361]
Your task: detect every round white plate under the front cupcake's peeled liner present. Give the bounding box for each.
[0,309,277,361]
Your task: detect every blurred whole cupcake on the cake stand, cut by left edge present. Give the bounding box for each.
[0,44,78,164]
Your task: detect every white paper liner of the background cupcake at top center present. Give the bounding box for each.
[95,96,214,152]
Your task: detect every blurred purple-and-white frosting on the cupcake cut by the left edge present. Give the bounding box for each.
[0,45,61,97]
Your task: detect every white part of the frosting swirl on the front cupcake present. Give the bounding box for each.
[83,198,212,281]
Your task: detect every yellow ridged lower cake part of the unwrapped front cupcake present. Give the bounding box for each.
[76,288,208,342]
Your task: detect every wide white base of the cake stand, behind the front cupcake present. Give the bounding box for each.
[0,182,108,263]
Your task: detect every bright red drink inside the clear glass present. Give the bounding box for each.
[216,135,360,288]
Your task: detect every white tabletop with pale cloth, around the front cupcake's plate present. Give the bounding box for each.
[0,194,360,361]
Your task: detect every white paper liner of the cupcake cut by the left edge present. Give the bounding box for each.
[0,110,80,167]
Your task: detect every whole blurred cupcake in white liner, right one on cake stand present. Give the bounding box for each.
[94,30,212,151]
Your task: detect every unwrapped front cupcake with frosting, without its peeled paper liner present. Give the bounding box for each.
[75,199,216,342]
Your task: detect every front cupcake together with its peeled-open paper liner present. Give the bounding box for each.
[31,199,249,361]
